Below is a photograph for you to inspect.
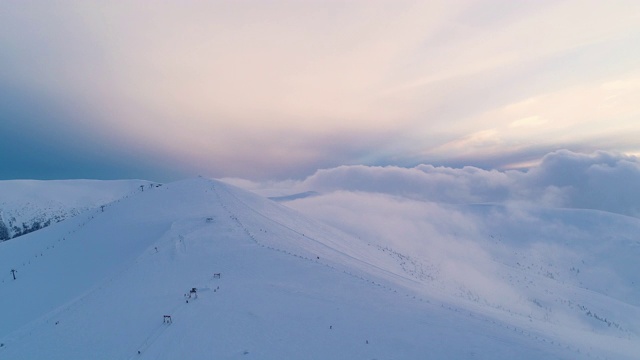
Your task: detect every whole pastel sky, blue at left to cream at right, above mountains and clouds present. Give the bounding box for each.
[0,0,640,182]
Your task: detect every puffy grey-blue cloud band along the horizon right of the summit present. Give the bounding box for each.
[232,150,640,216]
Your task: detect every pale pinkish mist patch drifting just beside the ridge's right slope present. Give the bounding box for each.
[286,191,522,309]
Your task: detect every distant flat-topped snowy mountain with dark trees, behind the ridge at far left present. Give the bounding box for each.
[0,180,156,241]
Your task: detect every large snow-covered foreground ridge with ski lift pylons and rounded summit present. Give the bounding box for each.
[0,178,640,360]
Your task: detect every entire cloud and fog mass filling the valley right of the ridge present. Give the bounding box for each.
[226,150,640,331]
